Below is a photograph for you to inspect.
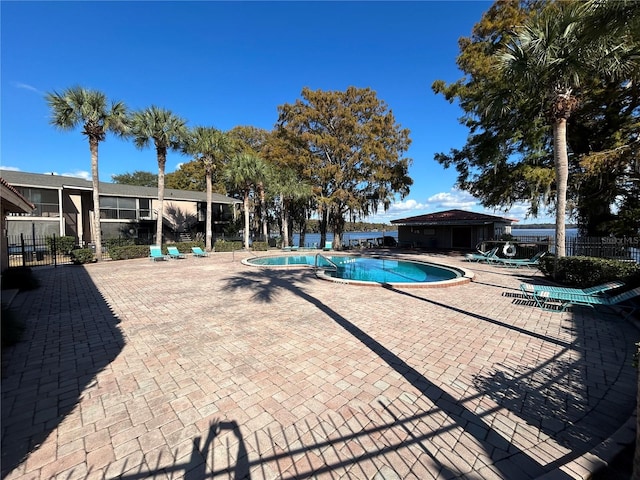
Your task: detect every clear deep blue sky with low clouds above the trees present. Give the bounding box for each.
[0,1,552,223]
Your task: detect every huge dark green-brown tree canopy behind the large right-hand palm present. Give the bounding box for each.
[432,0,640,233]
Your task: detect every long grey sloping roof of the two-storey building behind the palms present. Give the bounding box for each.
[0,170,242,204]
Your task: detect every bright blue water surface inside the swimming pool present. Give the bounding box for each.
[247,255,462,283]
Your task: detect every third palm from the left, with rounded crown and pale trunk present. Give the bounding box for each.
[184,127,232,251]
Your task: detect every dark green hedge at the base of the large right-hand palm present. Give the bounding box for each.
[540,255,640,288]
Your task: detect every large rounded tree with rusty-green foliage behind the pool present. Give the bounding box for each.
[277,87,413,247]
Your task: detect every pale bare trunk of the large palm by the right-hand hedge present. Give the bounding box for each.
[553,118,569,259]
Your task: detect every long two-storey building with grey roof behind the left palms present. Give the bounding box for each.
[0,170,242,247]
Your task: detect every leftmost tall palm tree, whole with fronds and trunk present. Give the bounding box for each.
[45,86,127,261]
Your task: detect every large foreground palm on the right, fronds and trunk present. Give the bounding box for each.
[499,2,633,258]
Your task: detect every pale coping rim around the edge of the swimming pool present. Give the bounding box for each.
[241,252,474,288]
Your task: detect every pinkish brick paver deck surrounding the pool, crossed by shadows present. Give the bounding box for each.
[2,253,640,480]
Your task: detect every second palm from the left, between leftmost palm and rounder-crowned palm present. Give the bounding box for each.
[130,105,188,245]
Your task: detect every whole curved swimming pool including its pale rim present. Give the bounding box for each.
[244,254,473,287]
